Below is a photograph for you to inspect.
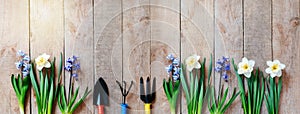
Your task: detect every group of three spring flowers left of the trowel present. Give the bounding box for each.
[11,50,91,114]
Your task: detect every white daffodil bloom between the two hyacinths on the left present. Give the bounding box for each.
[35,53,51,71]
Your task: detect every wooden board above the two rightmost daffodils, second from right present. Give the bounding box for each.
[244,0,272,113]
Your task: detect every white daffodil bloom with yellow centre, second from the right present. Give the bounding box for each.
[238,57,255,78]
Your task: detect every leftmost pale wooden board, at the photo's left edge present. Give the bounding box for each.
[0,0,30,114]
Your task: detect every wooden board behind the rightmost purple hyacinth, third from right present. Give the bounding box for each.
[215,0,244,113]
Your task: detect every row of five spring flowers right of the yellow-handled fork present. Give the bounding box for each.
[163,54,285,114]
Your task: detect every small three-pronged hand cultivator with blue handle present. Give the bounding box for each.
[116,81,133,114]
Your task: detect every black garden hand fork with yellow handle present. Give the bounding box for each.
[140,77,156,114]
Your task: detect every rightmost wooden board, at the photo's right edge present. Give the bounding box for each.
[272,0,300,114]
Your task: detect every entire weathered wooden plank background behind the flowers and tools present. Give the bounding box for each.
[0,0,300,114]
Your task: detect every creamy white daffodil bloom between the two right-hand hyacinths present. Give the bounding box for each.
[185,55,201,71]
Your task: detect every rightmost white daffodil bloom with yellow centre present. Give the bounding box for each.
[266,60,285,78]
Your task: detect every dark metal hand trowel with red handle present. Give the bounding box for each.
[93,77,109,114]
